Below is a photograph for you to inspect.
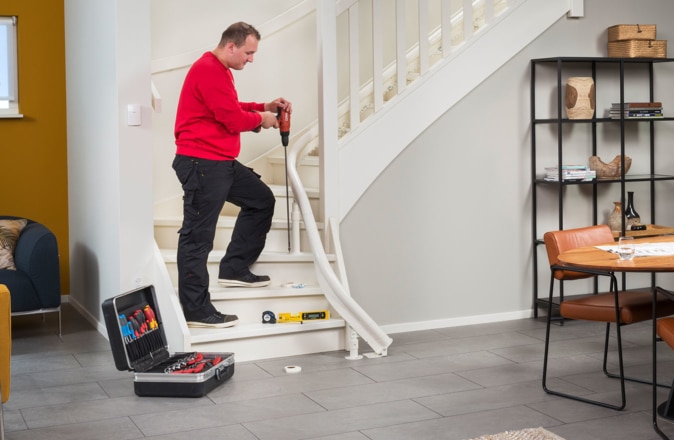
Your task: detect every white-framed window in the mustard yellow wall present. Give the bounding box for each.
[0,17,19,117]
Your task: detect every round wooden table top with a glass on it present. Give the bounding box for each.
[558,235,674,272]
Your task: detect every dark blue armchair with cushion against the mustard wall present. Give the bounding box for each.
[0,216,61,336]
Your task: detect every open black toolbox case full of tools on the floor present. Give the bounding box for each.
[102,285,234,397]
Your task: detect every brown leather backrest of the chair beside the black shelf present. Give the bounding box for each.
[543,225,615,280]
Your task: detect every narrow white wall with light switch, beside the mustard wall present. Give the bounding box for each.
[64,0,153,331]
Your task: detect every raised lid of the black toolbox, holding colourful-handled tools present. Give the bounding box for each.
[101,285,170,372]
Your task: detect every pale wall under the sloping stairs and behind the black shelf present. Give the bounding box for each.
[341,0,674,332]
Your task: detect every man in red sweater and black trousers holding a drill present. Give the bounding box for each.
[173,22,291,327]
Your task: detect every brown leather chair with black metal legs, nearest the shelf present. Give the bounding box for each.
[543,225,674,410]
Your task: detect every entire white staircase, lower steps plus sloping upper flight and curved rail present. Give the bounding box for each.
[155,0,566,361]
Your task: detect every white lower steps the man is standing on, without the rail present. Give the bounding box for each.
[155,144,347,361]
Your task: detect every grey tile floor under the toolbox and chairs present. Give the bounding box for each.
[4,304,674,440]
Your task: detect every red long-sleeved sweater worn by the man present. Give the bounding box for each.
[175,52,264,160]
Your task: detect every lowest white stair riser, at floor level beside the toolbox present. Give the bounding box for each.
[187,324,345,362]
